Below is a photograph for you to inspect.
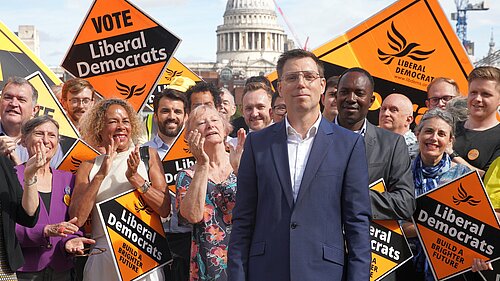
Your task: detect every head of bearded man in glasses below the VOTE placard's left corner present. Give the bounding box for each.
[61,78,95,128]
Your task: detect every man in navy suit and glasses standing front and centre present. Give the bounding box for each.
[228,49,371,281]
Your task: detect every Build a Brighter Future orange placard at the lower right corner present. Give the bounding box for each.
[412,172,500,280]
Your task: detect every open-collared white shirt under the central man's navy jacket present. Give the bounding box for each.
[285,113,321,201]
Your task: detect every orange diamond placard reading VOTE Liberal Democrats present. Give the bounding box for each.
[61,0,180,111]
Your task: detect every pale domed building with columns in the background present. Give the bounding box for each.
[186,0,294,100]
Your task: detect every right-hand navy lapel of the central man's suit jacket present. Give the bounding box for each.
[296,119,333,204]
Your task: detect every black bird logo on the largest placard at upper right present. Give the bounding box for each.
[377,22,436,64]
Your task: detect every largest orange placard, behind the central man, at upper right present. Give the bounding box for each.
[269,0,473,124]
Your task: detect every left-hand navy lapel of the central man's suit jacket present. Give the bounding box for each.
[271,121,293,209]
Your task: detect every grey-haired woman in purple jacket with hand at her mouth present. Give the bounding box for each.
[16,115,94,280]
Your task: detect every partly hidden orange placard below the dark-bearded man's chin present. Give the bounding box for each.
[162,129,195,196]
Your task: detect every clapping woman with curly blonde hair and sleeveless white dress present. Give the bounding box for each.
[69,99,170,280]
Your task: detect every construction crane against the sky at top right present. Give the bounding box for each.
[451,0,489,55]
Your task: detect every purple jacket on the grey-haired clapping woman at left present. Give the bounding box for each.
[16,165,76,272]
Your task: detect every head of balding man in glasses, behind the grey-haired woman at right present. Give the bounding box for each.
[425,77,460,110]
